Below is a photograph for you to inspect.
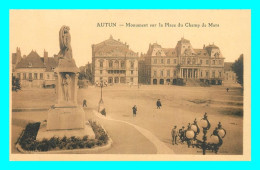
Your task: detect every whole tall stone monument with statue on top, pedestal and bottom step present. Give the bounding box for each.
[36,26,95,141]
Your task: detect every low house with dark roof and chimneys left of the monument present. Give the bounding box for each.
[12,49,58,88]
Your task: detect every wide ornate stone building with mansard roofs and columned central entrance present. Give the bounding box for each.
[142,38,224,85]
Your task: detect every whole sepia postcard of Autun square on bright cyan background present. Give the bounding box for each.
[9,10,251,161]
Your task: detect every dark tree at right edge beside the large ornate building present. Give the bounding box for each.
[232,54,244,87]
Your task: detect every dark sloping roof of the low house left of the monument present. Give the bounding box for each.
[16,51,45,68]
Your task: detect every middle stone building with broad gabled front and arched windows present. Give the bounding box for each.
[92,36,138,84]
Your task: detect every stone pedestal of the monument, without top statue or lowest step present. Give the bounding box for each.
[47,59,85,130]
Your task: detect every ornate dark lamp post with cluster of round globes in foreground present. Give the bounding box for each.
[182,113,226,155]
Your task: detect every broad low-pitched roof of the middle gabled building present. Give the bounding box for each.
[92,36,138,57]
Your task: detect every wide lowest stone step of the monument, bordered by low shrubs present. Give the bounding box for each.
[36,121,95,141]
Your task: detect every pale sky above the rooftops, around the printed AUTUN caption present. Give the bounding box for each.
[10,10,251,66]
